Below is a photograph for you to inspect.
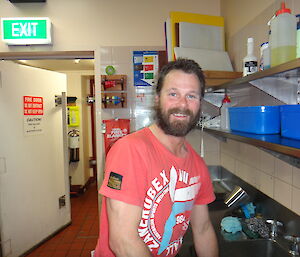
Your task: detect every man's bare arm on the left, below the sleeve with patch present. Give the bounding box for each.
[106,198,152,257]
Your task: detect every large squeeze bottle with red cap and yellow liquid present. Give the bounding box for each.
[271,2,297,67]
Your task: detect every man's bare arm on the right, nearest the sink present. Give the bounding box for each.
[191,205,219,257]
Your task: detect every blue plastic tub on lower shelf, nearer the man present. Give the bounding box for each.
[229,106,280,134]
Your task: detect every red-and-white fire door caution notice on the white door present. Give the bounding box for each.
[23,96,44,136]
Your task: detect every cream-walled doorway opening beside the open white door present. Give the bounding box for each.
[5,51,97,190]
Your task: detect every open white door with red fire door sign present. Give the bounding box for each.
[0,61,71,257]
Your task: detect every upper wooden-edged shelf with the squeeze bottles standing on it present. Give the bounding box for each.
[206,58,300,92]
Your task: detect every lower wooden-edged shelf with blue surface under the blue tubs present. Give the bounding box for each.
[204,128,300,158]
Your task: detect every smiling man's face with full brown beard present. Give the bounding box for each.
[156,70,201,137]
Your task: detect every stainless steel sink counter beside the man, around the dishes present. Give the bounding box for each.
[178,166,300,257]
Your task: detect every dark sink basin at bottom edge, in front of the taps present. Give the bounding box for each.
[220,239,291,257]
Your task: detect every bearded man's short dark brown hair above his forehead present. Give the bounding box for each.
[156,58,205,97]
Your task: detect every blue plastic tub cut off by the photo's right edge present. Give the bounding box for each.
[280,105,300,139]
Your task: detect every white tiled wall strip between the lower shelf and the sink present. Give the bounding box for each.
[220,140,300,215]
